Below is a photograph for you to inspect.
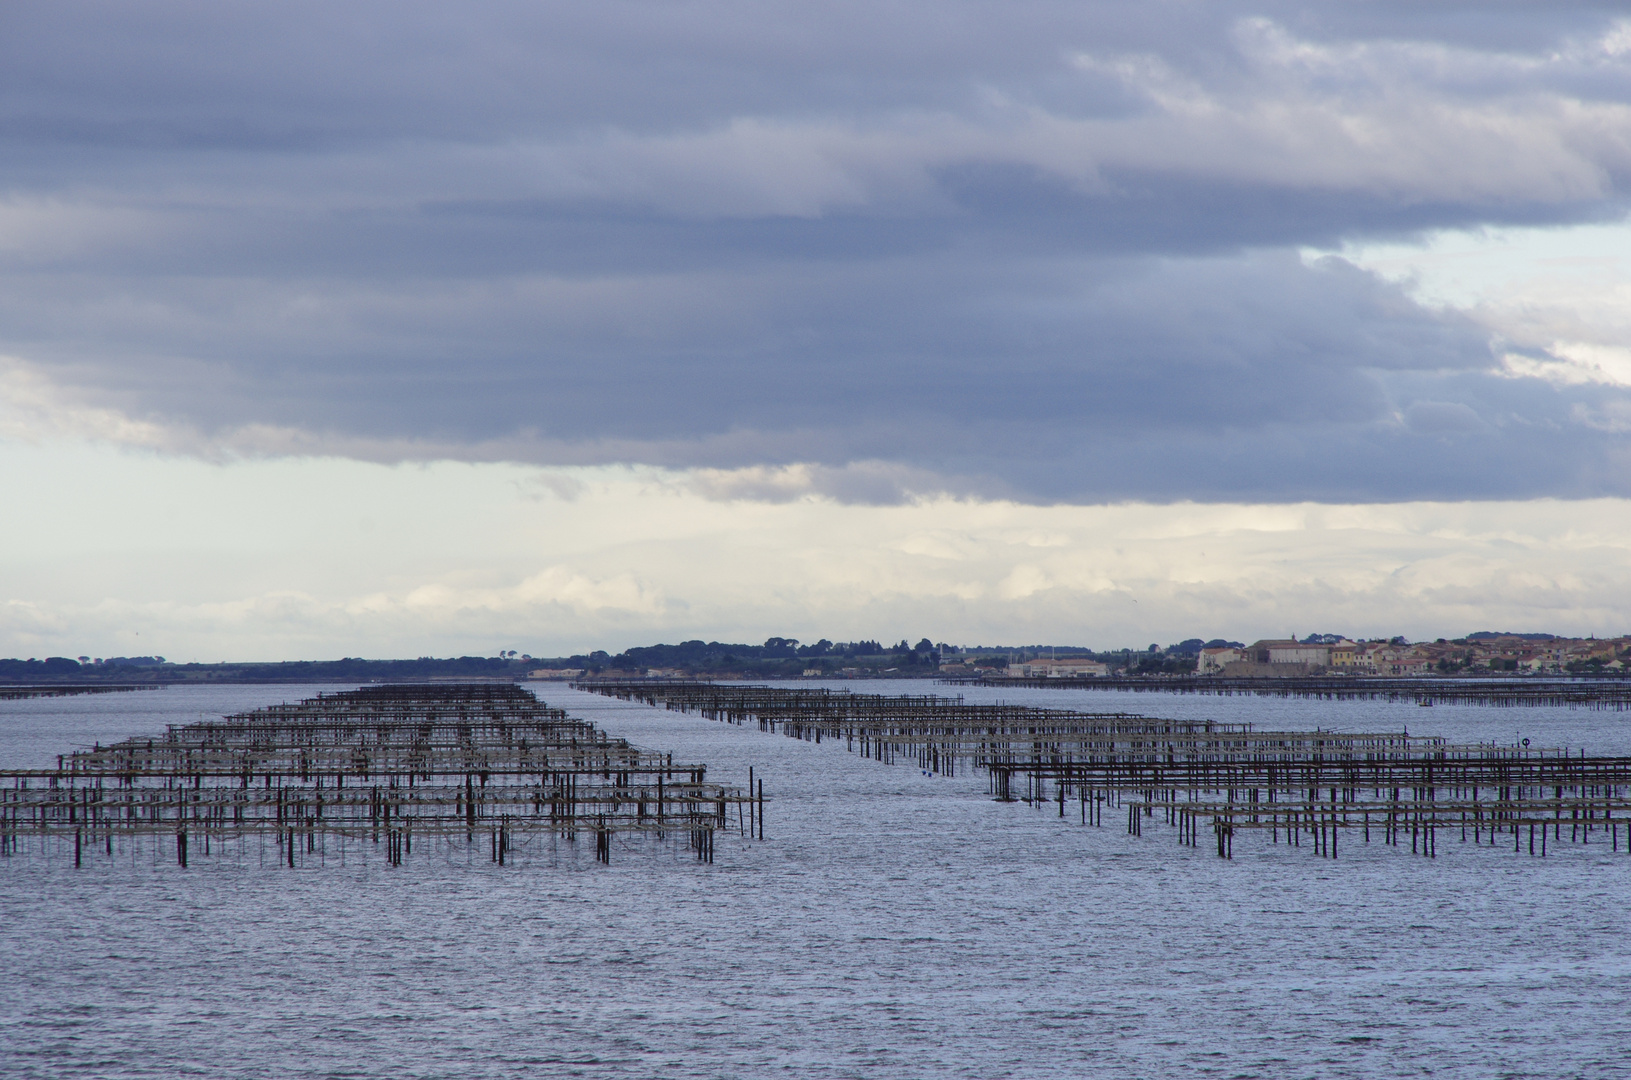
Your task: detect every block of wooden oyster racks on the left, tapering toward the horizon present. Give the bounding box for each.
[0,684,765,866]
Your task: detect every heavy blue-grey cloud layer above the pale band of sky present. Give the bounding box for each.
[0,3,1631,501]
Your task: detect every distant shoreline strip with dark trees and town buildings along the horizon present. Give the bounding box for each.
[0,631,1631,684]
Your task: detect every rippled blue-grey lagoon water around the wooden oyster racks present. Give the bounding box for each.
[0,684,1631,1080]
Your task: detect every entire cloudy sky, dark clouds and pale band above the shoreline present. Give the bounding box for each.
[0,0,1631,659]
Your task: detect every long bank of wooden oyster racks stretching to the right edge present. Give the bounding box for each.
[581,680,1631,858]
